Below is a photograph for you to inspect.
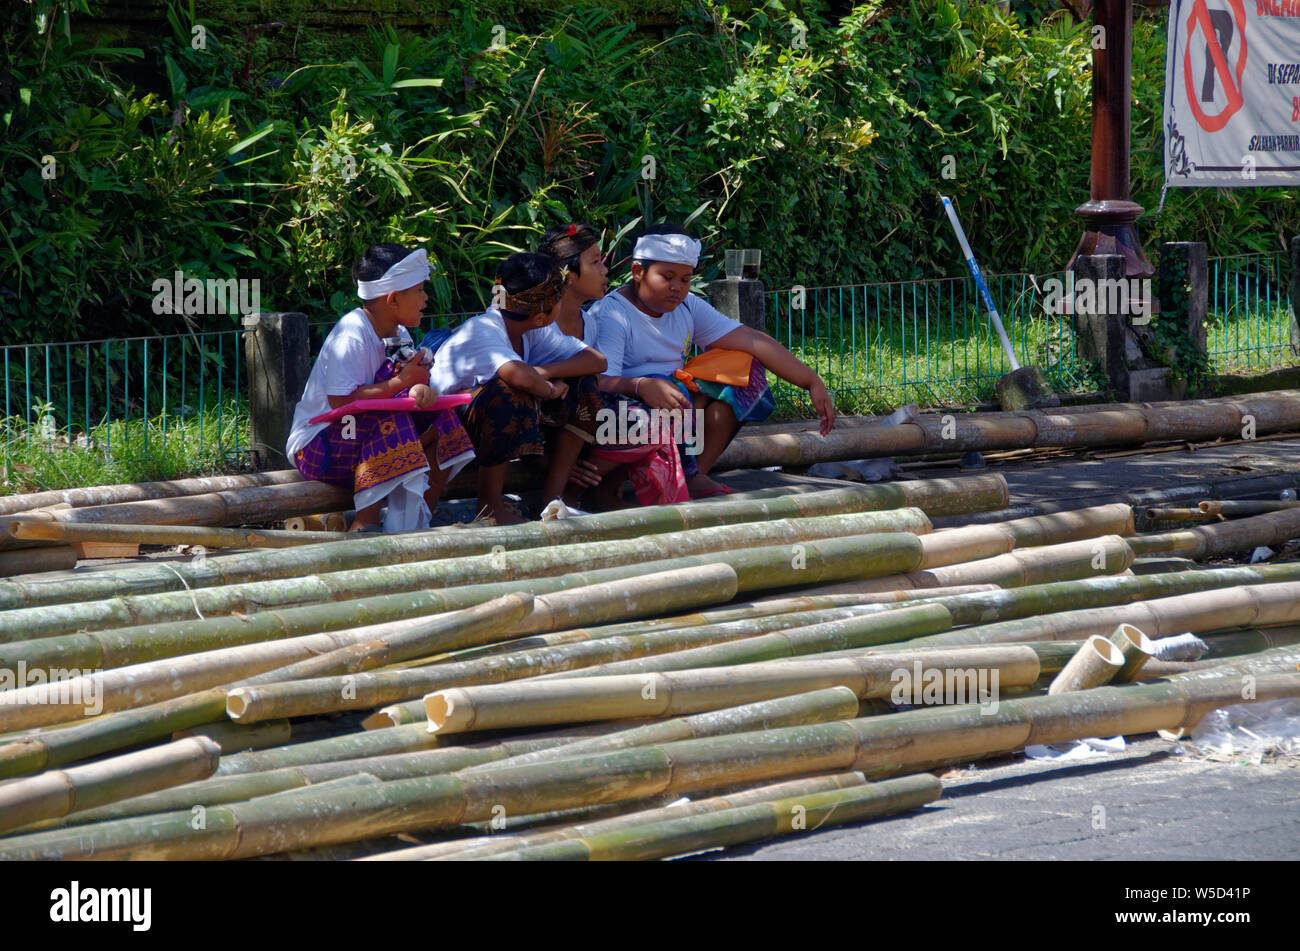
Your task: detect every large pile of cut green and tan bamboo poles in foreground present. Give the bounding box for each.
[0,465,1300,860]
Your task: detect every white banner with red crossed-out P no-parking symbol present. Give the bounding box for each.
[1165,0,1300,187]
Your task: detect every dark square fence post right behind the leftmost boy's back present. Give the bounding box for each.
[243,312,312,469]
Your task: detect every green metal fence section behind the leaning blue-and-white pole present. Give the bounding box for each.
[764,268,1088,412]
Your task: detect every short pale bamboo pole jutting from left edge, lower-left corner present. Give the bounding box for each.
[0,737,221,833]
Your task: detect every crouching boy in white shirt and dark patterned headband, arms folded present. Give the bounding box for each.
[430,255,605,525]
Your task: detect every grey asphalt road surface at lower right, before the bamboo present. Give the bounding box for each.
[717,737,1300,861]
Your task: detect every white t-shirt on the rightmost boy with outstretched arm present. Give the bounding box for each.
[586,290,741,377]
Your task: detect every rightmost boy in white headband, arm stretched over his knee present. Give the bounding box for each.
[590,225,835,499]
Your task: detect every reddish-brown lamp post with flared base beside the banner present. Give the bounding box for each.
[1066,0,1157,289]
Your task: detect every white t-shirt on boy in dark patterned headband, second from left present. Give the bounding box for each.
[429,307,585,394]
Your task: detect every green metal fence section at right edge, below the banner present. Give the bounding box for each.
[1206,253,1296,373]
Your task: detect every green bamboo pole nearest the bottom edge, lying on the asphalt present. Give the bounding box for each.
[482,773,944,861]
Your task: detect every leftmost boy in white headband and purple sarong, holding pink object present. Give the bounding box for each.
[286,244,473,531]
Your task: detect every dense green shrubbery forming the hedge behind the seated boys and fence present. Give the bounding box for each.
[0,0,1300,343]
